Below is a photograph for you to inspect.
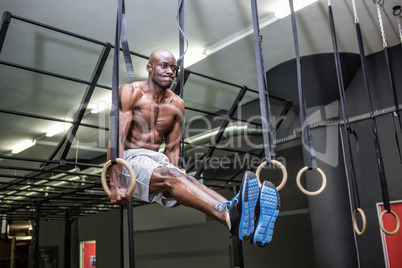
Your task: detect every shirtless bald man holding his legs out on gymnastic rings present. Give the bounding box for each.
[108,49,280,246]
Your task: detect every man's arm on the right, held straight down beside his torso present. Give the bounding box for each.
[164,99,184,167]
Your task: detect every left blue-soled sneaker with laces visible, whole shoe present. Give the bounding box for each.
[215,171,259,241]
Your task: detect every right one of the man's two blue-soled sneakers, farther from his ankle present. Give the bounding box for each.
[253,181,281,247]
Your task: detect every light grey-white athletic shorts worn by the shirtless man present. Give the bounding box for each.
[121,149,182,207]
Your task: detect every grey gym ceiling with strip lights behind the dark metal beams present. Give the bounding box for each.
[0,0,401,219]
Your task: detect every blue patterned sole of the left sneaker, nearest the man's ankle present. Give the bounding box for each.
[239,178,259,241]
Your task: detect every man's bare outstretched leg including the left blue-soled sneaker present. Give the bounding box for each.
[150,167,259,240]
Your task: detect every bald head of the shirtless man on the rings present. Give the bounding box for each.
[147,52,177,89]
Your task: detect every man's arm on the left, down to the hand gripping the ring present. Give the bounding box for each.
[107,84,137,204]
